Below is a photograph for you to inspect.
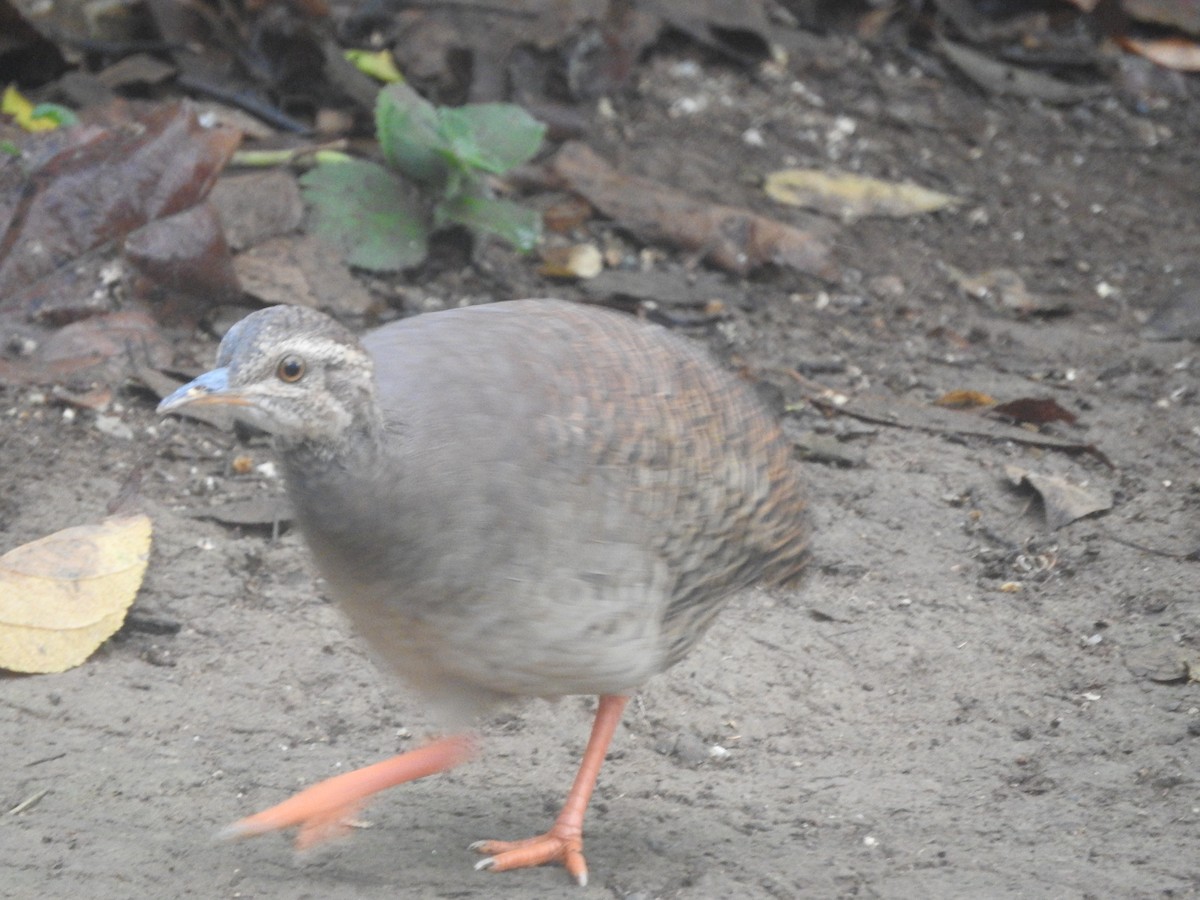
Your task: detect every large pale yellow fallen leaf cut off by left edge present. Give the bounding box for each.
[0,516,150,673]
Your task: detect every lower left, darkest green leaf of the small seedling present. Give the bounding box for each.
[300,160,428,271]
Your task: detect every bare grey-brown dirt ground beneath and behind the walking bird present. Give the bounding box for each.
[0,21,1200,900]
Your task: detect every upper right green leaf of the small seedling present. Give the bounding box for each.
[438,103,546,175]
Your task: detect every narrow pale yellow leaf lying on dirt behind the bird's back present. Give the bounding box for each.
[763,169,960,222]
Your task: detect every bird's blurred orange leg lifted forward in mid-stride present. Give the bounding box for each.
[222,734,475,850]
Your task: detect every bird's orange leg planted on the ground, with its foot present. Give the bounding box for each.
[470,695,629,886]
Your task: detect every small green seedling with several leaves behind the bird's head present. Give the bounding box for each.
[300,83,546,271]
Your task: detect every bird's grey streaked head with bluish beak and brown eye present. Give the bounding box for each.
[158,306,376,449]
